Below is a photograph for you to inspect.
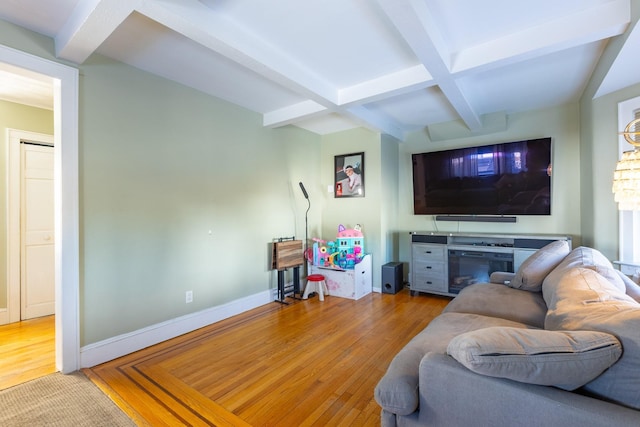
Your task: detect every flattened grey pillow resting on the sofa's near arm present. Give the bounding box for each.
[447,327,622,390]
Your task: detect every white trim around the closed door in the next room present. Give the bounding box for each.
[7,129,55,323]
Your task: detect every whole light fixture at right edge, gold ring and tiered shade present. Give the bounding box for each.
[613,119,640,211]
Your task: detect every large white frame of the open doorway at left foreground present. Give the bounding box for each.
[0,45,80,374]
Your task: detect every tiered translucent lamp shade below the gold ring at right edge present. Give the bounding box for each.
[613,150,640,211]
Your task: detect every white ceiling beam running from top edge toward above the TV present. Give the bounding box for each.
[378,0,482,130]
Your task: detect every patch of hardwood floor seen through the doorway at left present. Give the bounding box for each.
[0,316,56,390]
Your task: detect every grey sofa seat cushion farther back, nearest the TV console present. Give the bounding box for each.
[443,283,547,328]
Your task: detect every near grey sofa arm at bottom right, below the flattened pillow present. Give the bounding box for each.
[410,353,640,427]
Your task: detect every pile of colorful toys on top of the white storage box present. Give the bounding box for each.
[307,224,365,270]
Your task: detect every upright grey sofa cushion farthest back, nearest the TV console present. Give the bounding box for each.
[509,240,571,292]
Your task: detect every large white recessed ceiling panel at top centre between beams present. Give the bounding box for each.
[203,0,418,88]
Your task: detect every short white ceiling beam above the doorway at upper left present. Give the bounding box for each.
[55,0,140,64]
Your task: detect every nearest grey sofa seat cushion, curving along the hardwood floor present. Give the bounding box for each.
[374,313,528,415]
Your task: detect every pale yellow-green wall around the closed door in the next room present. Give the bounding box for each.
[0,100,53,309]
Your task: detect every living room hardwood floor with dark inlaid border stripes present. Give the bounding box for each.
[84,290,449,426]
